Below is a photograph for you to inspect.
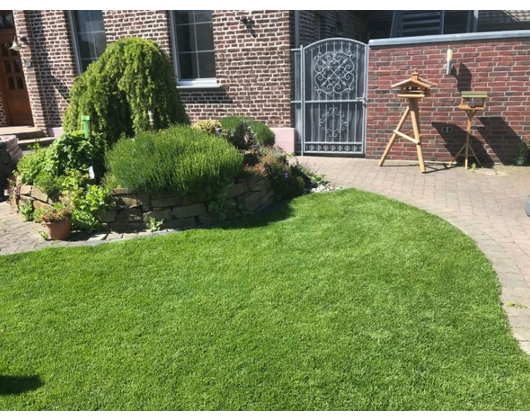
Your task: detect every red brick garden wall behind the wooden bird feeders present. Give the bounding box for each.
[367,40,530,164]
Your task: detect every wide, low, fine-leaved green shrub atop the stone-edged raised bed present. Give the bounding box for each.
[107,126,243,198]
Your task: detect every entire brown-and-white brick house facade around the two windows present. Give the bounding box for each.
[0,10,293,132]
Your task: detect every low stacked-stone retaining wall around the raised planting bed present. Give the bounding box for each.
[16,176,274,231]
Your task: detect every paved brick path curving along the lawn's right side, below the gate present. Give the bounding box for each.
[299,157,530,353]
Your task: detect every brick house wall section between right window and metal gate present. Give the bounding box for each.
[181,10,291,127]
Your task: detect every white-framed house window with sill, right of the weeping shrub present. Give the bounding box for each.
[173,10,216,86]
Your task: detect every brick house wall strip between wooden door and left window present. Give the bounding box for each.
[14,10,77,128]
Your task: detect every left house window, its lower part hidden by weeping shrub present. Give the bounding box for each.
[70,10,107,72]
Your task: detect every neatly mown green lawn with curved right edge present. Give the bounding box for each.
[0,191,530,410]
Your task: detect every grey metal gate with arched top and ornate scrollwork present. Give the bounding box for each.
[293,38,368,155]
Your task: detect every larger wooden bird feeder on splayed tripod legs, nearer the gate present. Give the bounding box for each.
[379,70,437,173]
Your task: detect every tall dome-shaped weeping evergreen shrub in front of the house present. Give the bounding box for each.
[64,38,189,143]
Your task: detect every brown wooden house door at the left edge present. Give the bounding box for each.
[0,10,33,125]
